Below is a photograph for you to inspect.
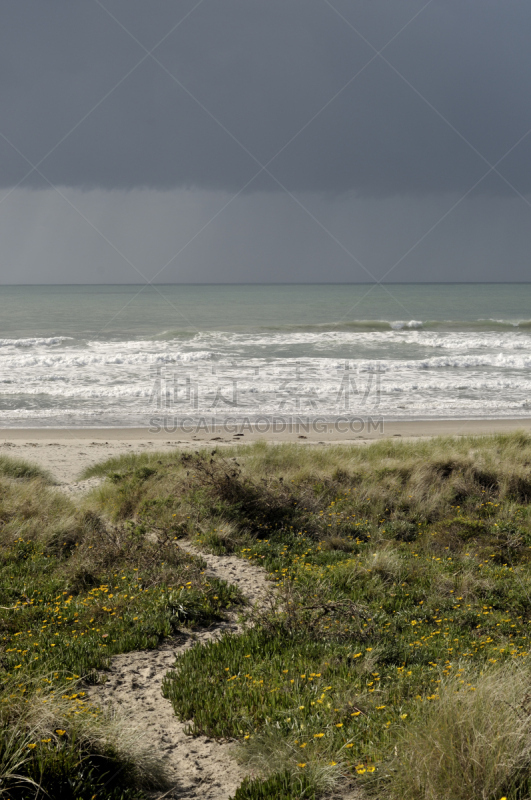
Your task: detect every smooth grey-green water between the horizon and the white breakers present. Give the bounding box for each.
[0,284,531,337]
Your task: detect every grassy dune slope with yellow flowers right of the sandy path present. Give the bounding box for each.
[84,435,531,800]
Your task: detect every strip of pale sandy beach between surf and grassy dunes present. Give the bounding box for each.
[0,419,531,489]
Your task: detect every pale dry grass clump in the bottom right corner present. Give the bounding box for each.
[389,663,531,800]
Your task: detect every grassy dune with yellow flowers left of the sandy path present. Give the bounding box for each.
[0,459,241,800]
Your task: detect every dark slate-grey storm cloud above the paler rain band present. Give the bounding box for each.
[0,0,531,196]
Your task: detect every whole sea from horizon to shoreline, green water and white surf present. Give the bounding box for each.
[0,284,531,428]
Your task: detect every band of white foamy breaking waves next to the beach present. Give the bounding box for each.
[0,320,531,425]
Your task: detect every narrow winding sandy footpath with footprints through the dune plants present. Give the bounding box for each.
[91,543,270,800]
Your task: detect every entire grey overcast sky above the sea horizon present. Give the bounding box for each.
[0,0,531,283]
